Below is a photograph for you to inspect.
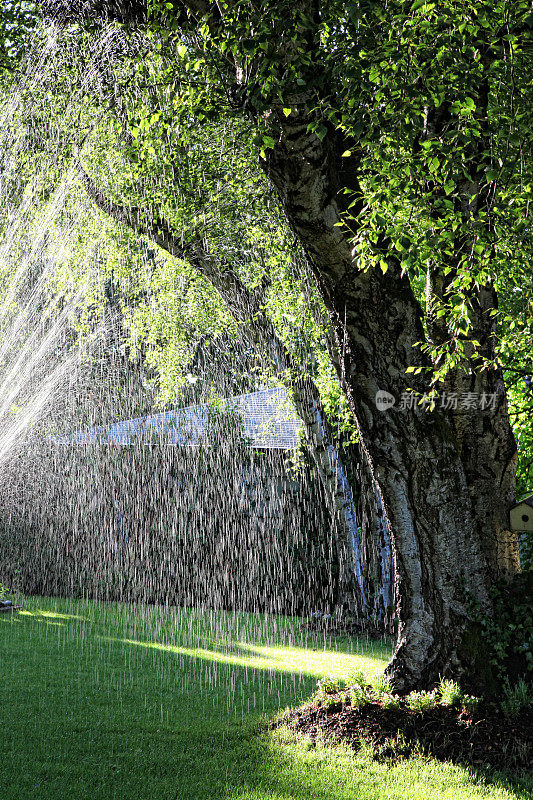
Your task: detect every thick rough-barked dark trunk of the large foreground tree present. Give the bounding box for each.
[265,111,517,690]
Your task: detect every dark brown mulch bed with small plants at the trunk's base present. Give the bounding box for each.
[273,695,533,772]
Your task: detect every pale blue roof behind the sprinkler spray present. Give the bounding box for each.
[54,389,302,450]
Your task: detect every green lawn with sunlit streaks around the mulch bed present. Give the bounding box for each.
[0,598,533,800]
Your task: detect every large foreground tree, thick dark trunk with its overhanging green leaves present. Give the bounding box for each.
[39,0,532,690]
